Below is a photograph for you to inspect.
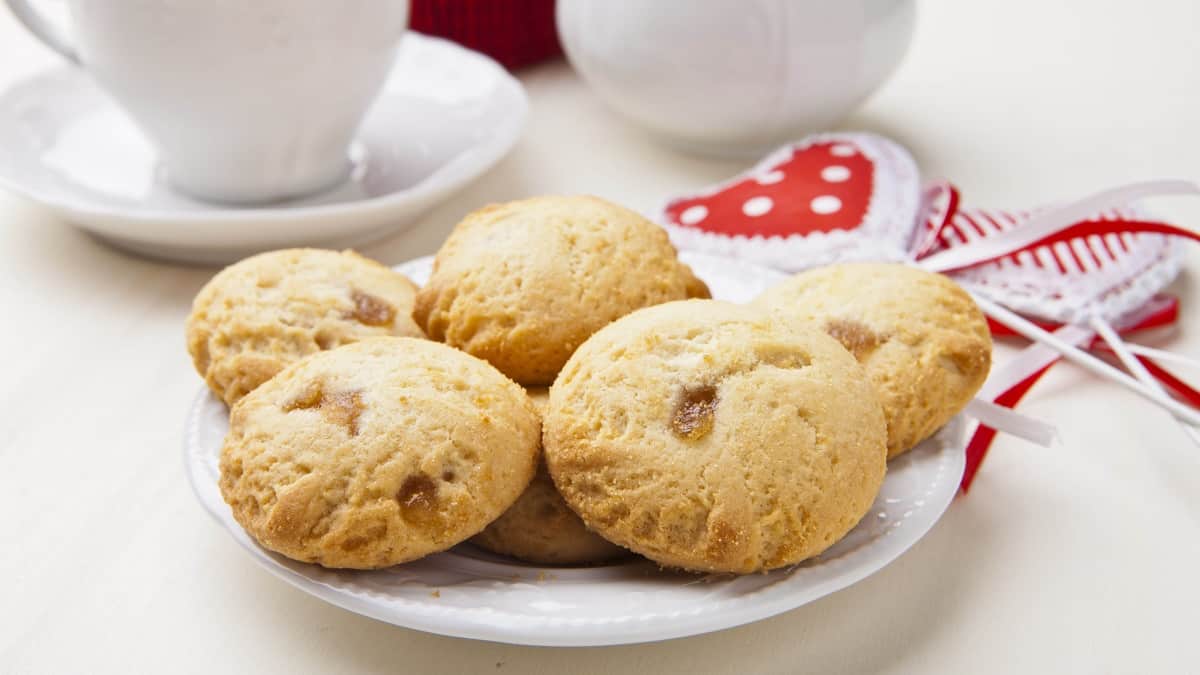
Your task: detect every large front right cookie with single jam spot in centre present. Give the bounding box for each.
[542,300,887,573]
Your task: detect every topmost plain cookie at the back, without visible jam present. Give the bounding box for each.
[413,197,708,386]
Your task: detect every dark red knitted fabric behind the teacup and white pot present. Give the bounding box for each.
[409,0,563,68]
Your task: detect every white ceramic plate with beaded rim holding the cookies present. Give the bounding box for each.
[184,255,965,646]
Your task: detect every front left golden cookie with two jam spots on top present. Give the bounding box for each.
[220,338,540,569]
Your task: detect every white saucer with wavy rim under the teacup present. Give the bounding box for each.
[0,32,529,263]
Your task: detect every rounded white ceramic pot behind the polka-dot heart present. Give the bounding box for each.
[558,0,916,156]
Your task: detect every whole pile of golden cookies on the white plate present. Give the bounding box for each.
[187,192,991,573]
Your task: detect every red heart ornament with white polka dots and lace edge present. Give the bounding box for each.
[660,133,920,270]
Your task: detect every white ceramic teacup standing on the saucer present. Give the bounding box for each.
[7,0,409,203]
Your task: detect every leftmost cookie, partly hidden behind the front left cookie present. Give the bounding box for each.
[187,249,424,406]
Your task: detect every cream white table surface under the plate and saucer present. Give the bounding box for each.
[0,0,1200,674]
